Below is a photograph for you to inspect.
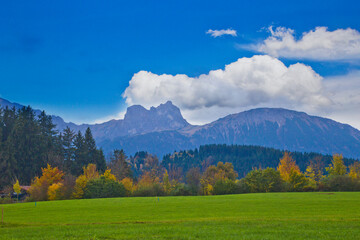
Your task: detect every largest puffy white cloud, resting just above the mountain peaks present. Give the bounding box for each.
[122,55,331,123]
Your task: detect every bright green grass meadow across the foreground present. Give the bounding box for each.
[0,193,360,239]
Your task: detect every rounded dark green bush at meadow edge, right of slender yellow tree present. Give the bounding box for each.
[84,176,126,198]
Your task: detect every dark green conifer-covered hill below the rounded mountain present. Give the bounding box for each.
[161,144,354,177]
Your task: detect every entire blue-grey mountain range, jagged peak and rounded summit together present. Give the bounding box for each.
[0,98,360,158]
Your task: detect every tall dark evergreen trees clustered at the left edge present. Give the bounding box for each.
[0,107,106,190]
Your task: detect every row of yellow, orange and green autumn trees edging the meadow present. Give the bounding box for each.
[3,150,360,201]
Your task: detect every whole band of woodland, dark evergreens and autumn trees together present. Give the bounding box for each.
[0,107,360,201]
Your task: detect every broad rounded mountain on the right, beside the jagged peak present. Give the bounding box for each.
[185,108,360,157]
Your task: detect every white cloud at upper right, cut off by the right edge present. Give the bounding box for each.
[247,27,360,61]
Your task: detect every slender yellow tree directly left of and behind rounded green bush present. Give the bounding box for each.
[73,163,99,198]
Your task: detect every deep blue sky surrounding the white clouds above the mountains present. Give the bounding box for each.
[0,1,360,125]
